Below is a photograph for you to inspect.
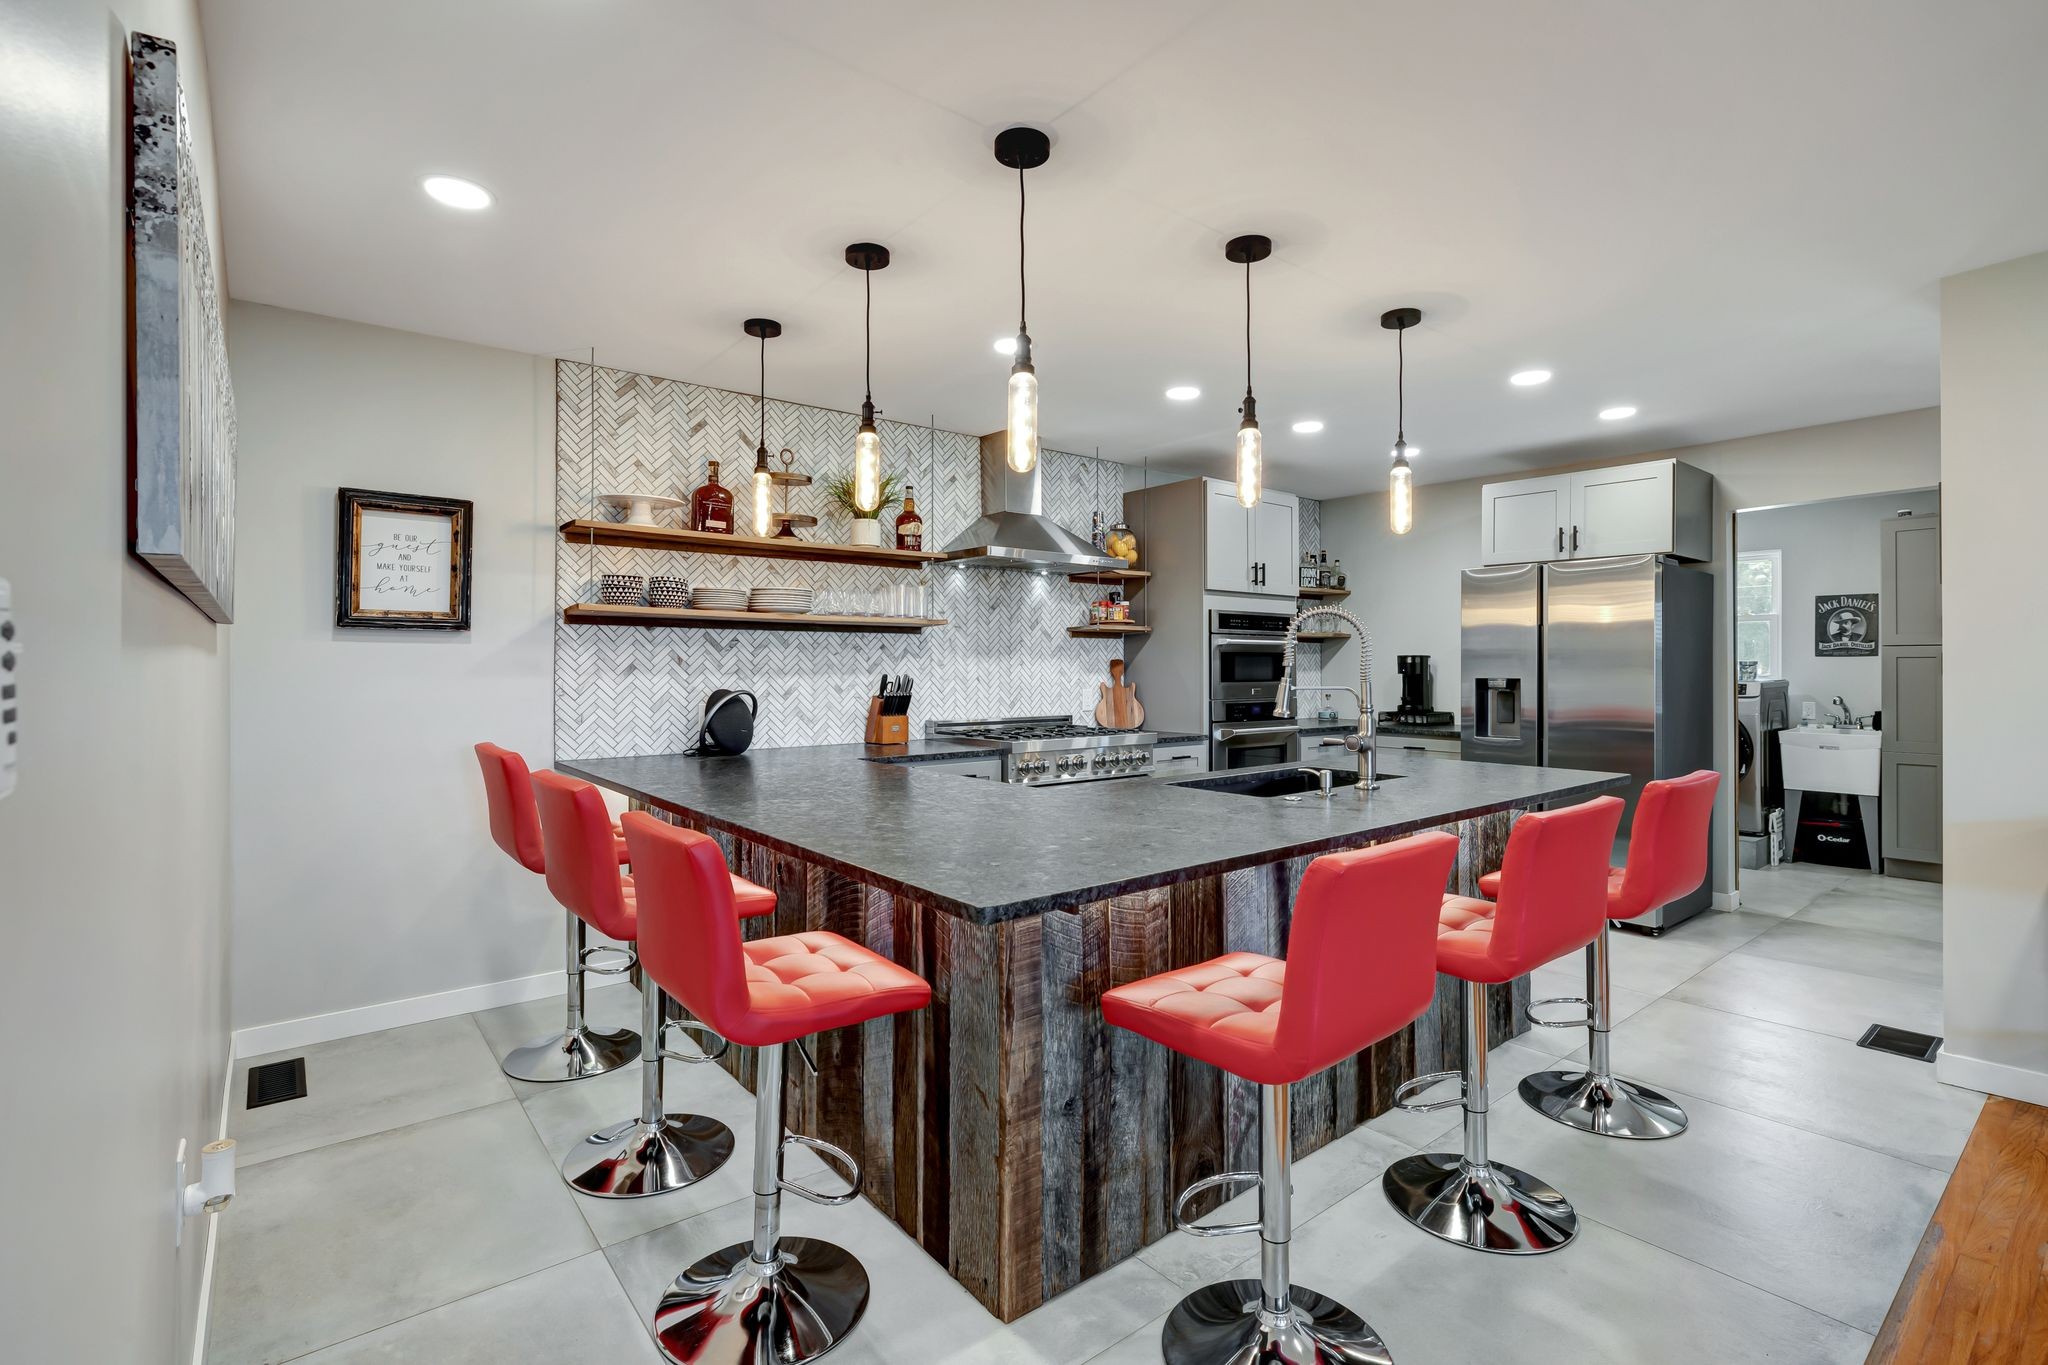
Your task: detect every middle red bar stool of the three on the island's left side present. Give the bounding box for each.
[532,772,774,1199]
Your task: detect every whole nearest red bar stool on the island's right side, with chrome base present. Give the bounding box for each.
[1102,833,1458,1365]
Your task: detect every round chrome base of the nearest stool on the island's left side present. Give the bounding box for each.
[653,1236,868,1365]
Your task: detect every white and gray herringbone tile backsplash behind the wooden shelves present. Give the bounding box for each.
[555,360,1317,759]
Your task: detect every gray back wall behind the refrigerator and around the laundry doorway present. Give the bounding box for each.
[1323,407,1954,892]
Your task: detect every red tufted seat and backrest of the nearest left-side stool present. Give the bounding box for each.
[625,810,932,1048]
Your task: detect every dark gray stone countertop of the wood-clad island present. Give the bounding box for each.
[557,745,1628,923]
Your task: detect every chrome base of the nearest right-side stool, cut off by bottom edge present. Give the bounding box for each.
[1161,1279,1393,1365]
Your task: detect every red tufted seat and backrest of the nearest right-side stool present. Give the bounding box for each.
[1102,833,1458,1085]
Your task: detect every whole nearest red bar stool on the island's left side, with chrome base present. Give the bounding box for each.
[625,812,932,1365]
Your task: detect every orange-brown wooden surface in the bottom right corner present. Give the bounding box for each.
[1868,1097,2048,1365]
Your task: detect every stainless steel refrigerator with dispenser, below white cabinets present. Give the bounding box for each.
[1458,555,1714,929]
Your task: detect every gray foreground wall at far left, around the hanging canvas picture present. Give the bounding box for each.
[0,0,231,1365]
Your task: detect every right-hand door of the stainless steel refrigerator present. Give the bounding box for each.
[1542,555,1659,841]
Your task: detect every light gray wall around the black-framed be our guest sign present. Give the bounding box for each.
[229,303,561,1050]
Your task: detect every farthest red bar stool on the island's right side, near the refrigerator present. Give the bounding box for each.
[1515,767,1720,1138]
